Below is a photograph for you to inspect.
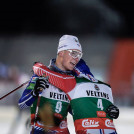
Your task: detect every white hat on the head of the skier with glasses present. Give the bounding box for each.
[57,35,82,54]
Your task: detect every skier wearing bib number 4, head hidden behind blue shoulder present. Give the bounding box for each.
[60,63,119,134]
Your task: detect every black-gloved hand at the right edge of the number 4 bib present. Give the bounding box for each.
[106,104,119,119]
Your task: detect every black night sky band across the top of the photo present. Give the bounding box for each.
[0,0,134,38]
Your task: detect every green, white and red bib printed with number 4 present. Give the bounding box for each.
[67,78,115,132]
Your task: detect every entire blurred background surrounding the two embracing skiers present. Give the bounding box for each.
[0,0,134,134]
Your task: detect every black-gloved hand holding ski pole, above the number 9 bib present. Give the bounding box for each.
[32,77,49,96]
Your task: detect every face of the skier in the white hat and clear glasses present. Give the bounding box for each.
[62,50,82,71]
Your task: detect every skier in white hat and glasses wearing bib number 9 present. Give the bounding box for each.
[19,35,85,134]
